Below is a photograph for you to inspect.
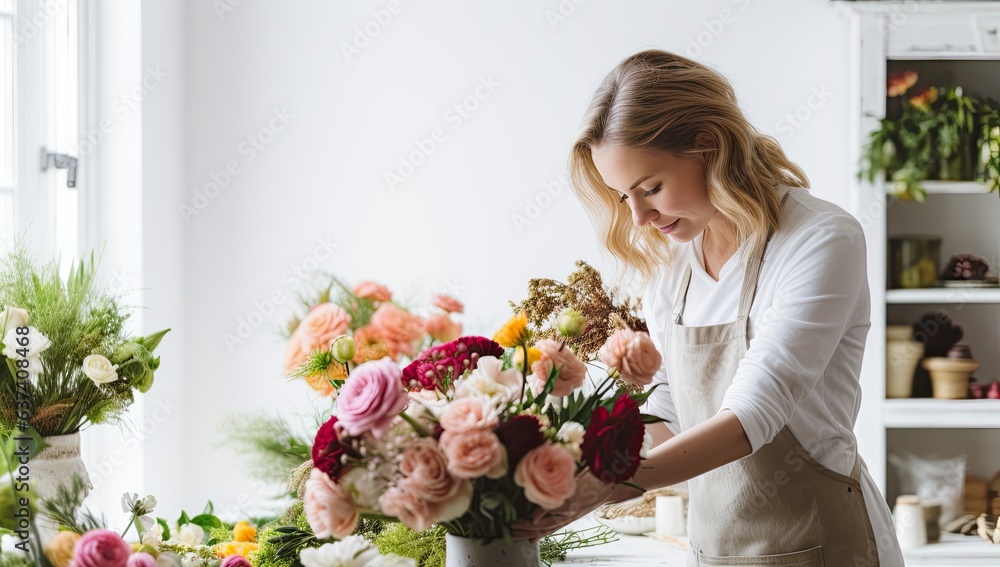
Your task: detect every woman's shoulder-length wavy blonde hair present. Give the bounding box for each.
[570,50,809,284]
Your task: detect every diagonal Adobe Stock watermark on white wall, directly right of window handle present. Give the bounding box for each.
[178,107,296,224]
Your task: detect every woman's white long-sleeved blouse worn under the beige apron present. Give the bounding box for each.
[643,188,903,567]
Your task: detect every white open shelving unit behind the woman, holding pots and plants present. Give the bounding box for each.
[838,0,1000,567]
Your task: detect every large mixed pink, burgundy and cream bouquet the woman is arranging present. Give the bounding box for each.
[303,264,661,541]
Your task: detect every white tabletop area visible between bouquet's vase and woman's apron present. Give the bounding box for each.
[553,515,688,567]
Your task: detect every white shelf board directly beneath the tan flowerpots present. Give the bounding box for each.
[882,398,1000,430]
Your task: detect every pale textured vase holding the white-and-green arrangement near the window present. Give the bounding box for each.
[28,432,93,544]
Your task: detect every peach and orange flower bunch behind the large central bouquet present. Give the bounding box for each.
[283,277,464,396]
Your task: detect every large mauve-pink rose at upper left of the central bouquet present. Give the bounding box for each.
[337,357,409,437]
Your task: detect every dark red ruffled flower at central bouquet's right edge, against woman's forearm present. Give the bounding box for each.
[580,394,645,484]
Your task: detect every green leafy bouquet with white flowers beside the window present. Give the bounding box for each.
[0,245,169,437]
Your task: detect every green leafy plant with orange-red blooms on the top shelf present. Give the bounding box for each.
[859,71,1000,202]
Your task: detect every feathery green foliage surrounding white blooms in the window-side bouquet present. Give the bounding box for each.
[0,242,166,437]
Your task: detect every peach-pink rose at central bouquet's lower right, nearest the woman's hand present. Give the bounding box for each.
[514,443,576,510]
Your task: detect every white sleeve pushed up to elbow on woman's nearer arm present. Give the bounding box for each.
[720,215,870,451]
